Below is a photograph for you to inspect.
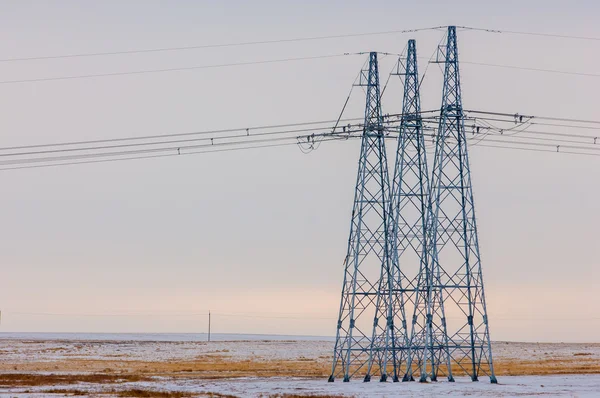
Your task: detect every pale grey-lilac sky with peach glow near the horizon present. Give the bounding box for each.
[0,0,600,342]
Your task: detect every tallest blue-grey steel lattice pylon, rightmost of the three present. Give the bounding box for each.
[421,26,497,383]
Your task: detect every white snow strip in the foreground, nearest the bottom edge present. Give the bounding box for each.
[0,375,600,398]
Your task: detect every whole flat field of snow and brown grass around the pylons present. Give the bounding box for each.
[0,338,600,397]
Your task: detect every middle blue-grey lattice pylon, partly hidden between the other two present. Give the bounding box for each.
[382,40,429,381]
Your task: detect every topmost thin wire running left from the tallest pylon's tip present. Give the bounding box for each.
[0,26,447,62]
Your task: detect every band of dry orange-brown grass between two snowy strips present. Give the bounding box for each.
[0,353,600,388]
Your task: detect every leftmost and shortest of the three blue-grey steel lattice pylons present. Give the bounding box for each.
[329,52,392,381]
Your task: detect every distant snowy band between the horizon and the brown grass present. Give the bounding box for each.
[0,334,600,361]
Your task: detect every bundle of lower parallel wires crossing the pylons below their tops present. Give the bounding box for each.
[0,111,600,170]
